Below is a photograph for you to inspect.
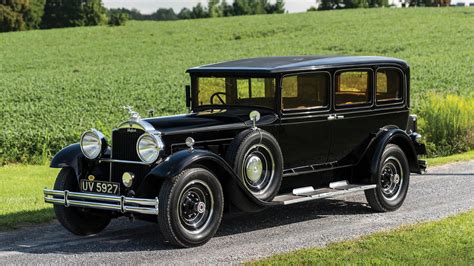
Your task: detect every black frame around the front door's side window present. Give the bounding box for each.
[278,70,332,114]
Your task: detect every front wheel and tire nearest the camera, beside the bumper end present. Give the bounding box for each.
[158,168,224,247]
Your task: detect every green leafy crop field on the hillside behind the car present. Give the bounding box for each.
[0,8,474,164]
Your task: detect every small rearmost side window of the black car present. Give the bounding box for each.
[376,68,403,103]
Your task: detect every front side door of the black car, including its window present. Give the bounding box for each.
[278,72,331,169]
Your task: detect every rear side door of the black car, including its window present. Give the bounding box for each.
[328,68,376,165]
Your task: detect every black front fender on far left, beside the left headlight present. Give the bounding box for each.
[49,143,84,177]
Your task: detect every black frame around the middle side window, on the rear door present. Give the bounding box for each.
[332,67,375,111]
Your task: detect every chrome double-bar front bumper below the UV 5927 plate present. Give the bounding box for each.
[43,188,159,215]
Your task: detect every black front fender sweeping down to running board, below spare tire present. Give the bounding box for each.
[138,149,273,210]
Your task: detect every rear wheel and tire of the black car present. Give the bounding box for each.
[365,144,410,212]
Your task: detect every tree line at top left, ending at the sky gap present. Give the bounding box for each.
[0,0,285,32]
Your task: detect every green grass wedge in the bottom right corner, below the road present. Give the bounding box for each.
[249,210,474,265]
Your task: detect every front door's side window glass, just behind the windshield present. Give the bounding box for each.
[282,73,330,110]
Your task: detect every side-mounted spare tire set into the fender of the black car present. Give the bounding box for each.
[226,129,283,201]
